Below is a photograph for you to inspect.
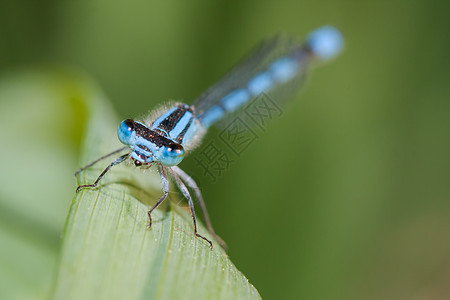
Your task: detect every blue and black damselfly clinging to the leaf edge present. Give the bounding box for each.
[75,26,343,248]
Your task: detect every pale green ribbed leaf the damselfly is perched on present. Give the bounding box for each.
[53,71,260,299]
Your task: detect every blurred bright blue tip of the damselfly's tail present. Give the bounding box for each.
[306,25,344,60]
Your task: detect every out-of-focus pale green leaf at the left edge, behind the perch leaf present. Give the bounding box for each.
[0,69,92,299]
